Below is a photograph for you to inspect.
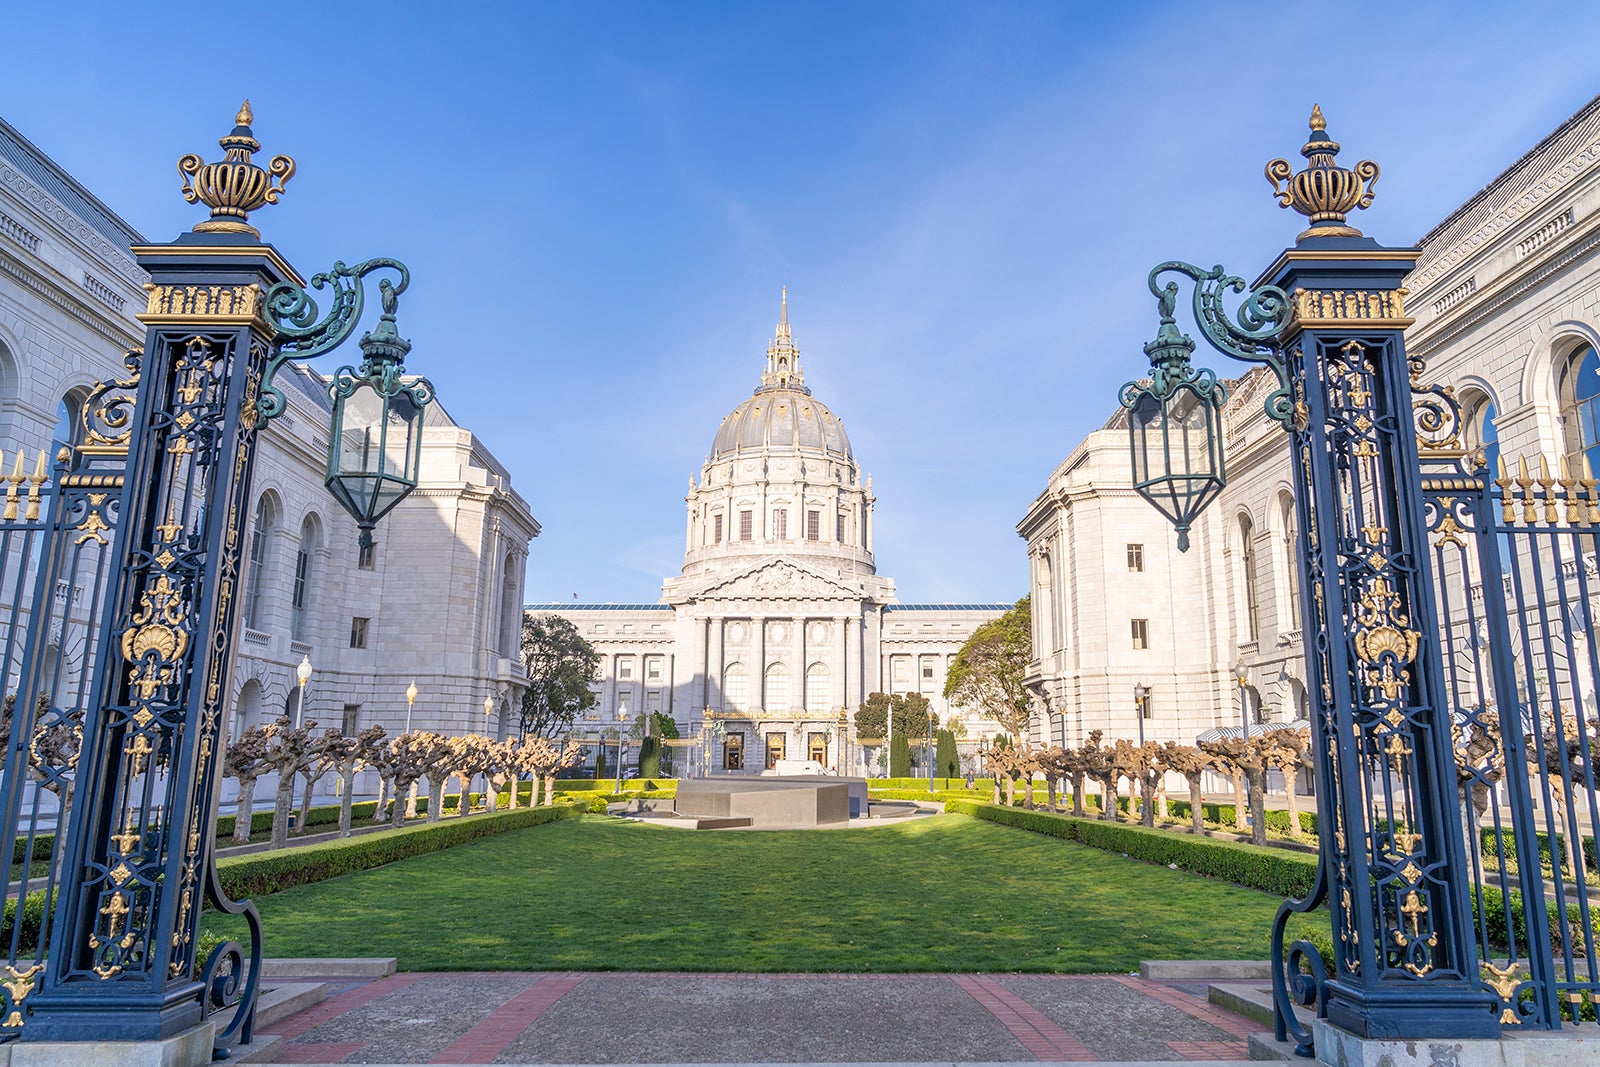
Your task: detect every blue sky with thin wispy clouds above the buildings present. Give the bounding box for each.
[0,2,1600,601]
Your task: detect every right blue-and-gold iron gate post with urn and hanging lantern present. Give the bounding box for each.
[1120,107,1491,1053]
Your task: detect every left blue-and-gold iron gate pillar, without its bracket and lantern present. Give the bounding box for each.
[21,109,301,1041]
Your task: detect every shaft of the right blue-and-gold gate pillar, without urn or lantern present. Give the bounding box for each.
[1261,235,1499,1038]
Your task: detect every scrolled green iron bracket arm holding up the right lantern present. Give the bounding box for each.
[1149,259,1294,427]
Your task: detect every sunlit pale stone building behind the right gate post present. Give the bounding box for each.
[1018,98,1600,742]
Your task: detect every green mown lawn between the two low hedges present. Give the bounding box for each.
[205,816,1278,973]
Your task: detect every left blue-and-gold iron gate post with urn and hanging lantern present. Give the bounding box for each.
[19,102,432,1048]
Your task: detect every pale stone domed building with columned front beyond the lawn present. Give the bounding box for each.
[526,291,1011,774]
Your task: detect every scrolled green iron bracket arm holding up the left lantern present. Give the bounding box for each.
[258,256,409,419]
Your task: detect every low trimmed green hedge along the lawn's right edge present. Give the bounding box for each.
[944,800,1317,897]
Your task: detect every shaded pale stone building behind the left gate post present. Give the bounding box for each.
[0,110,539,733]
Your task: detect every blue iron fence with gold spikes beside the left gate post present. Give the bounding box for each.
[0,361,261,1041]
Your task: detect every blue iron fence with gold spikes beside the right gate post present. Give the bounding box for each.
[1422,438,1600,1027]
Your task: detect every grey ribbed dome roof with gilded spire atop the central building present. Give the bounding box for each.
[710,288,854,462]
